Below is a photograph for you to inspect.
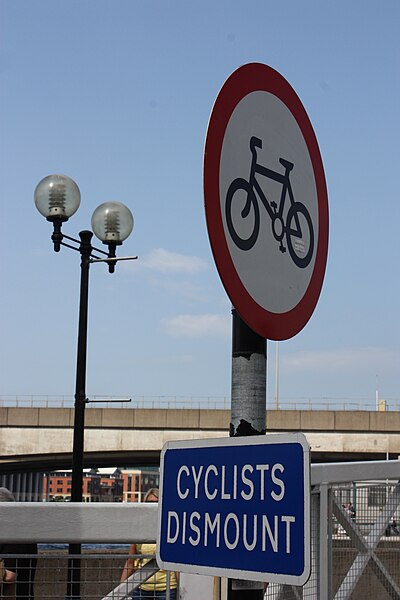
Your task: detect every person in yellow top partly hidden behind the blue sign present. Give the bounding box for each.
[121,488,178,600]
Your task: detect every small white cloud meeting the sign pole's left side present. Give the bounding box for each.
[162,314,231,338]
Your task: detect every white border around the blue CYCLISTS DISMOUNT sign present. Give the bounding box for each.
[156,432,311,586]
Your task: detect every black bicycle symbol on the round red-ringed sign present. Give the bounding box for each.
[225,136,314,269]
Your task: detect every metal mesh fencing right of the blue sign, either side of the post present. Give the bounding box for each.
[265,480,400,600]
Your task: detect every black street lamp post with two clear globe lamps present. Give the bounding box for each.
[35,175,136,599]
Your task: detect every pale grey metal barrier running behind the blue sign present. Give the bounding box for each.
[0,461,400,600]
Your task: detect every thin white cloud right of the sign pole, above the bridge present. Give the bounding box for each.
[281,346,400,373]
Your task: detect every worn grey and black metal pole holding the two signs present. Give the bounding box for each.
[228,308,267,600]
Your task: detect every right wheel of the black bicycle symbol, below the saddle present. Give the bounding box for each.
[286,202,314,269]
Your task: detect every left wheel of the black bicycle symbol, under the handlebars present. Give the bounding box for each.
[225,177,260,250]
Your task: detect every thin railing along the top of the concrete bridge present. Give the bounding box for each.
[0,395,400,412]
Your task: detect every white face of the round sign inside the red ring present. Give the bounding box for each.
[220,91,318,313]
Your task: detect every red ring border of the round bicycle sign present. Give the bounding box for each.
[203,63,329,340]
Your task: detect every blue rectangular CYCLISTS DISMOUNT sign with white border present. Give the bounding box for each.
[157,433,310,585]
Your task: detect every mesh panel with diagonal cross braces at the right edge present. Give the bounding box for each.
[332,481,400,600]
